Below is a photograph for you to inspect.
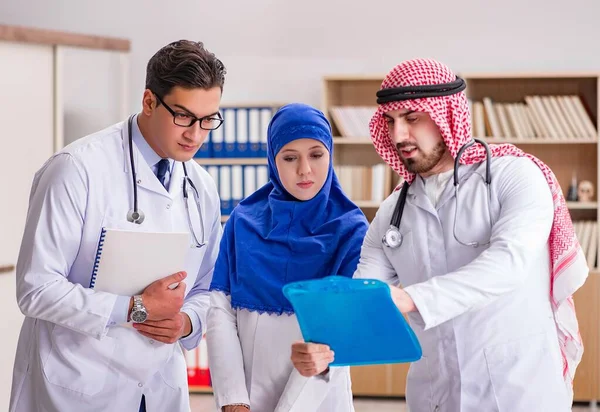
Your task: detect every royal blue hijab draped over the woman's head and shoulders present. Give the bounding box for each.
[210,103,368,315]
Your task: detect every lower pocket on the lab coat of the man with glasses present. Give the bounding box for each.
[43,325,115,396]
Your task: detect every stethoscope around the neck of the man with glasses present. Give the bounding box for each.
[127,115,206,248]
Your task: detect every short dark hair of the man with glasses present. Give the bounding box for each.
[146,40,227,98]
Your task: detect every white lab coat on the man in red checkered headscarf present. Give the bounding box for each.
[354,157,571,412]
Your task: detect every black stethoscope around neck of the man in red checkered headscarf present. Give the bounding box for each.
[381,139,492,249]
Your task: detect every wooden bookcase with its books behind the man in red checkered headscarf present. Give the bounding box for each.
[321,72,600,401]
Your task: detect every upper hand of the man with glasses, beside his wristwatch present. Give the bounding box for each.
[137,272,187,323]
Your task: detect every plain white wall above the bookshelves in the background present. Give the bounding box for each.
[0,0,600,119]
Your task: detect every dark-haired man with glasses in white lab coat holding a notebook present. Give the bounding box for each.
[10,40,226,412]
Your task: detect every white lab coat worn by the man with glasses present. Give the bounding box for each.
[10,122,221,412]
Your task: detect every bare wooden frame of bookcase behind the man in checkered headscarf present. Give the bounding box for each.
[321,72,600,402]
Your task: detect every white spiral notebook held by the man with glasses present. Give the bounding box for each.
[90,228,190,296]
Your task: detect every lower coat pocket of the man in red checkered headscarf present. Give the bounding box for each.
[484,333,570,412]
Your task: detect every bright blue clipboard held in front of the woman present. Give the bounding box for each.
[283,276,422,366]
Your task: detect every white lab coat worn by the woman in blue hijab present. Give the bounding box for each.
[206,291,354,412]
